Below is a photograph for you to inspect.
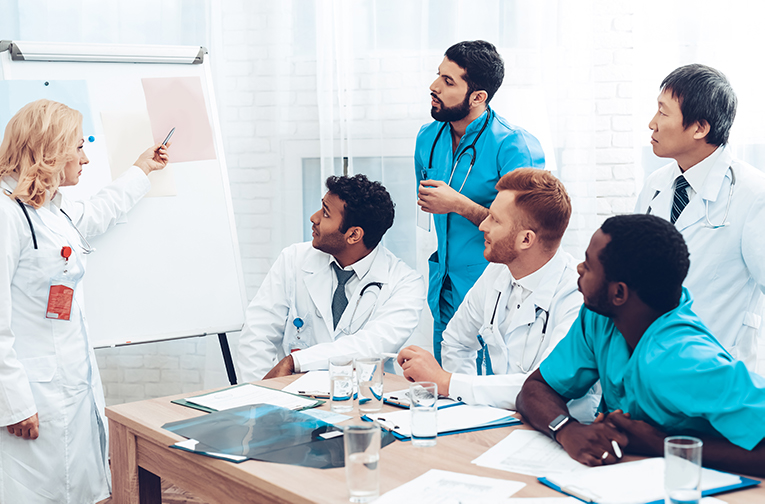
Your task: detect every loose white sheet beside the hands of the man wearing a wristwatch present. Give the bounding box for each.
[472,430,587,477]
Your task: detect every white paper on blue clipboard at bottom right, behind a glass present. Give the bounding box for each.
[543,457,741,504]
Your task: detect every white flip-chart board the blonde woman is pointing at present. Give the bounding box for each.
[0,46,247,348]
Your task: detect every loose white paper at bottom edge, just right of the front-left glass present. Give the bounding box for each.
[375,469,526,504]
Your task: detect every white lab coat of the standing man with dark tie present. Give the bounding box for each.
[635,147,765,371]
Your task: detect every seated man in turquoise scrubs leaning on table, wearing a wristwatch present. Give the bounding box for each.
[517,215,765,476]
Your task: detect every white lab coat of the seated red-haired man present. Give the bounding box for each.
[441,249,600,421]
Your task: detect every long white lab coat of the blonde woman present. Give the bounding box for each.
[0,167,150,504]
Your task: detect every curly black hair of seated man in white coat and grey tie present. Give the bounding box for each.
[327,173,395,249]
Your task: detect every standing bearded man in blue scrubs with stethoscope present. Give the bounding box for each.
[414,40,544,363]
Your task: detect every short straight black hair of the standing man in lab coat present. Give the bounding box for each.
[661,63,738,146]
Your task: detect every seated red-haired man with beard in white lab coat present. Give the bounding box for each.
[398,168,599,420]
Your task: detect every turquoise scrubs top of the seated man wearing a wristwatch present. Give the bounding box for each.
[539,288,765,450]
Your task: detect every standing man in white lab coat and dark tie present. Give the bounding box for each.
[635,64,765,371]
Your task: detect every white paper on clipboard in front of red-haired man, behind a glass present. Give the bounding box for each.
[367,404,520,438]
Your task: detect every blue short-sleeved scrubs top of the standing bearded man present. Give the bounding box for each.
[414,109,545,320]
